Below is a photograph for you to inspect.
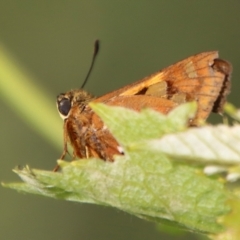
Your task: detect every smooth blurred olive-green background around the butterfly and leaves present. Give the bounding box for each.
[0,0,240,240]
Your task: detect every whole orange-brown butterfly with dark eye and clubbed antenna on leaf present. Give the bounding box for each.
[55,41,231,170]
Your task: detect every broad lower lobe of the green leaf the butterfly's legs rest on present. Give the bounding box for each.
[1,155,229,232]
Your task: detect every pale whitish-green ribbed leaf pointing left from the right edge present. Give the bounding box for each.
[143,125,240,165]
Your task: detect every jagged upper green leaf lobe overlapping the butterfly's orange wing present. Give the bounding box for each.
[90,102,197,145]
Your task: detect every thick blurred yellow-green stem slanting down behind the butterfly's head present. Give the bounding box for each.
[0,44,63,148]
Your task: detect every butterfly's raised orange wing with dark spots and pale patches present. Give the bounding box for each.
[96,51,231,125]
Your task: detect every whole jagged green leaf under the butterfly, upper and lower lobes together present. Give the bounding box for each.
[4,103,232,234]
